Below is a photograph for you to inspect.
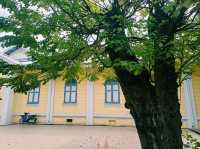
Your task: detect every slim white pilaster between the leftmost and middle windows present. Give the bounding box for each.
[47,80,55,124]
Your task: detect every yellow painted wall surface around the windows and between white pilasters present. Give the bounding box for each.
[0,73,200,127]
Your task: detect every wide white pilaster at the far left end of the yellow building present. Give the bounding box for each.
[0,86,14,125]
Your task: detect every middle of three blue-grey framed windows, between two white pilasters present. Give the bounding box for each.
[64,80,77,103]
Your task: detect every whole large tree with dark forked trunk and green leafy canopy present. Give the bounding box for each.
[0,0,200,149]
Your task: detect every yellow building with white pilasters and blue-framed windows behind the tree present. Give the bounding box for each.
[0,49,200,128]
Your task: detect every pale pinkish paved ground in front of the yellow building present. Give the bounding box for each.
[0,125,140,149]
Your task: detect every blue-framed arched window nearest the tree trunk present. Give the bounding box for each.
[105,80,120,104]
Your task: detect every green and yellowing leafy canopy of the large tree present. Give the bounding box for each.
[0,0,200,92]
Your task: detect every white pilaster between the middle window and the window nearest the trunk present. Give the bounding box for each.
[86,80,94,125]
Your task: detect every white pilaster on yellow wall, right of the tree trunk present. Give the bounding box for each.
[184,78,197,128]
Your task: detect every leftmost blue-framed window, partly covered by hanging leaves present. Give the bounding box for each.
[28,87,40,104]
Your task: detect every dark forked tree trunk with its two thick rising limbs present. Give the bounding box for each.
[105,3,183,149]
